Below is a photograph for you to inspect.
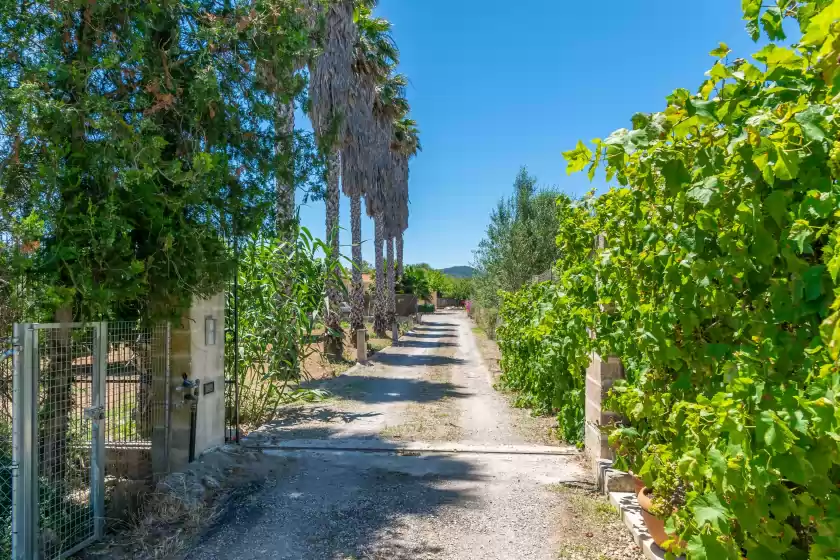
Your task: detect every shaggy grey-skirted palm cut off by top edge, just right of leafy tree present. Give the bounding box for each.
[309,0,356,359]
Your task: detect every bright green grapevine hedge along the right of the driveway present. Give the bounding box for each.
[501,0,840,560]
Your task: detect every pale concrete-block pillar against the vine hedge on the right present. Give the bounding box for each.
[584,352,624,462]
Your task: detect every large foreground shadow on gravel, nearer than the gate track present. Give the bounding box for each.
[186,431,484,560]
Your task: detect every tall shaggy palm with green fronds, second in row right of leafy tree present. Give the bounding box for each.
[341,2,399,340]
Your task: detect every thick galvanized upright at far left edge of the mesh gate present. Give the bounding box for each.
[12,323,39,560]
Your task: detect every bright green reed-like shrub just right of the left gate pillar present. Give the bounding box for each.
[225,224,342,429]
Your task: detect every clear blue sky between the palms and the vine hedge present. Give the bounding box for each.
[301,0,757,268]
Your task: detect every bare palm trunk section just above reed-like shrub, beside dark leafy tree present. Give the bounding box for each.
[275,101,295,237]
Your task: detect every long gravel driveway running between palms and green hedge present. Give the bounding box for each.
[187,313,641,560]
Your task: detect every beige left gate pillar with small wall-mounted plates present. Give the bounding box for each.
[152,294,225,476]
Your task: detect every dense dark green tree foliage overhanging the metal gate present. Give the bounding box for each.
[0,0,309,319]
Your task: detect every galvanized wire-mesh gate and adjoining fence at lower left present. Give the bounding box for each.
[9,322,169,560]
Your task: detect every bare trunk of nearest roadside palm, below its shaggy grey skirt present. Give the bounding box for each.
[324,150,344,360]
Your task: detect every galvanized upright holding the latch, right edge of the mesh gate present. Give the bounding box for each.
[90,321,108,539]
